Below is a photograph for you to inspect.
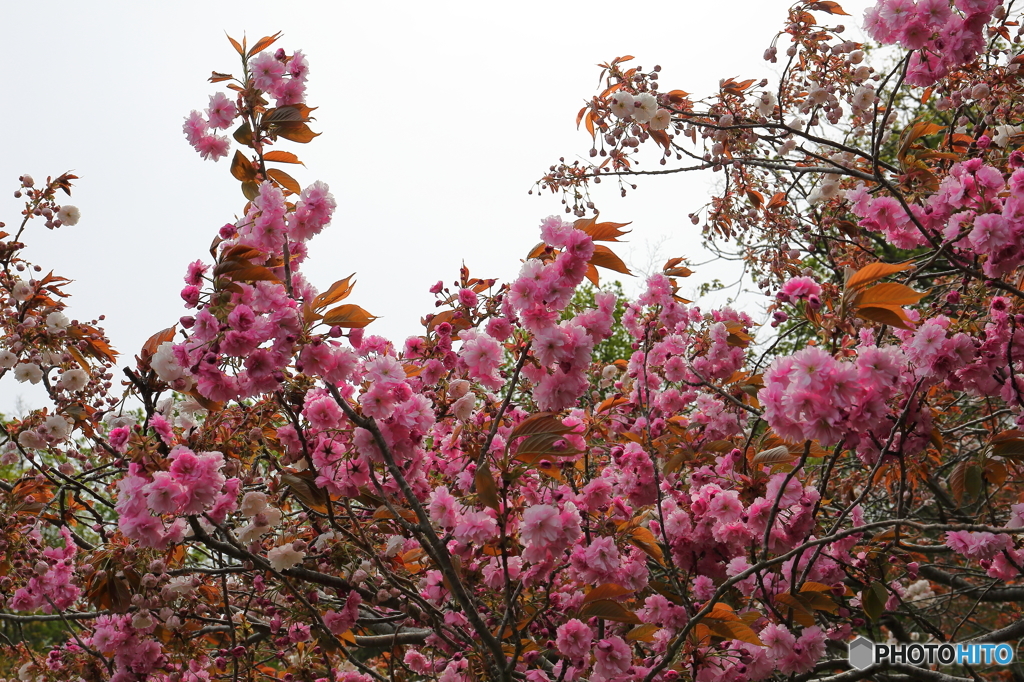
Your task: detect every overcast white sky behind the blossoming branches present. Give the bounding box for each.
[0,0,870,414]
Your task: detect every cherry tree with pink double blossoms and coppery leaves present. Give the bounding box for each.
[0,0,1024,682]
